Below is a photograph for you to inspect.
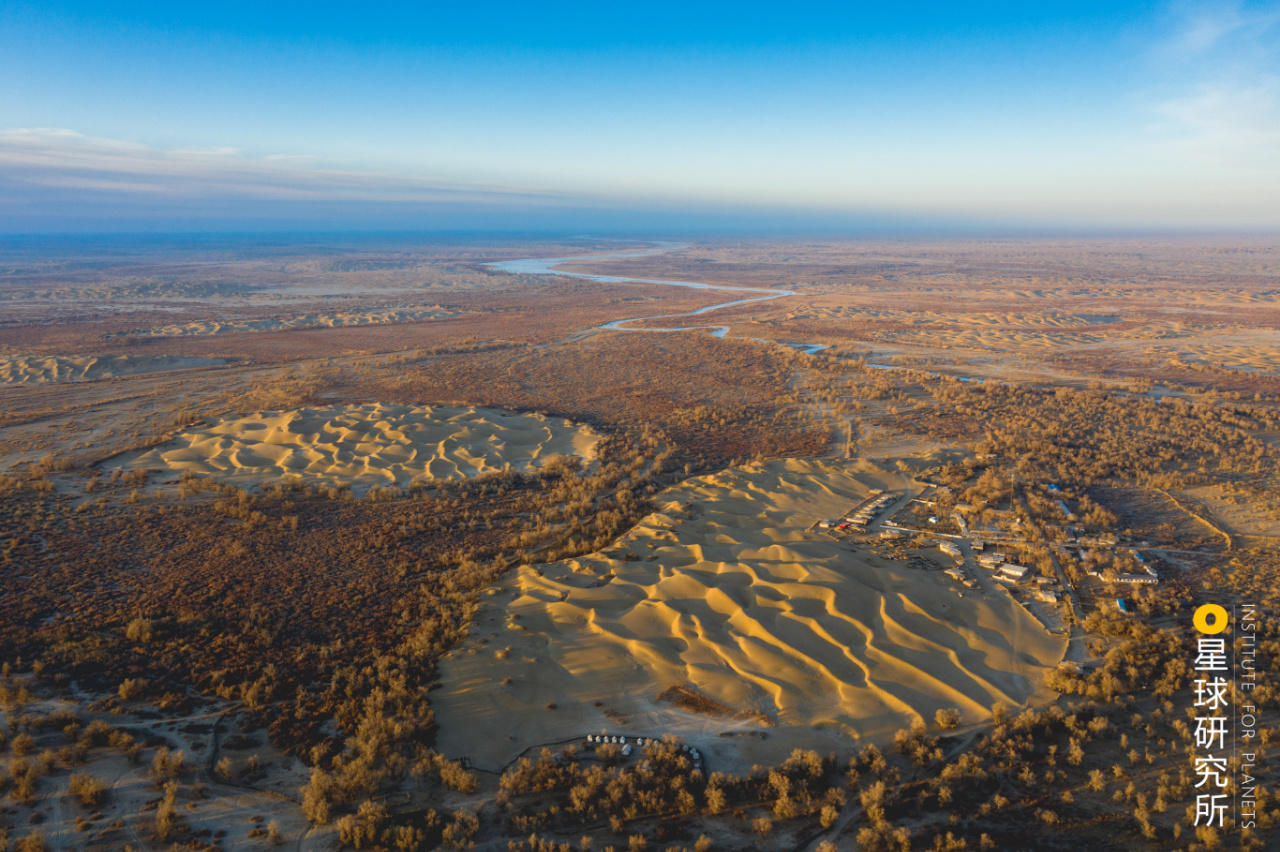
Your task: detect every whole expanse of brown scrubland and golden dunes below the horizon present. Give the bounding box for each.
[0,234,1280,852]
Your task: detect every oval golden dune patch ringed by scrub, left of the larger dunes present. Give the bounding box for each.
[111,403,600,486]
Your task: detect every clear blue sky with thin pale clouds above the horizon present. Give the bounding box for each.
[0,3,1280,233]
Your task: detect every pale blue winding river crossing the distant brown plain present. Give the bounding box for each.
[488,243,827,354]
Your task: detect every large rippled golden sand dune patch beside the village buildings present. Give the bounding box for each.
[433,459,1065,766]
